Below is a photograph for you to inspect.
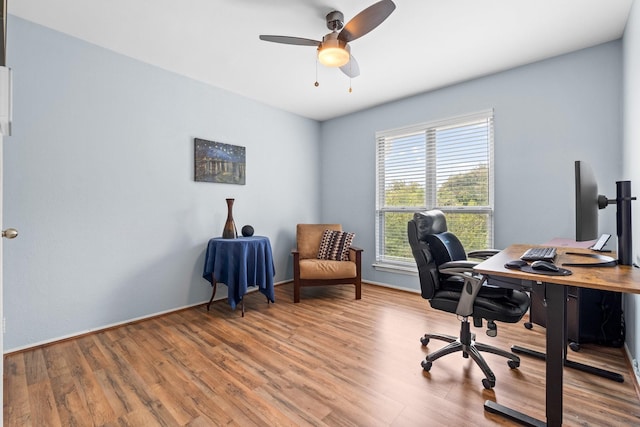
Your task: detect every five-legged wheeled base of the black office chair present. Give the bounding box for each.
[420,318,520,390]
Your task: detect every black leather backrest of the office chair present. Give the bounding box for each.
[407,209,467,299]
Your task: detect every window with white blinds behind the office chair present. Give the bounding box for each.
[376,111,493,267]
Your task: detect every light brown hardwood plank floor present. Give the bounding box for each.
[4,284,640,427]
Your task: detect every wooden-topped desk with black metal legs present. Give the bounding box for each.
[475,244,640,426]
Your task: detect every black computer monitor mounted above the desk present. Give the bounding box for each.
[575,160,602,242]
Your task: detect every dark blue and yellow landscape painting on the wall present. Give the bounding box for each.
[194,138,246,185]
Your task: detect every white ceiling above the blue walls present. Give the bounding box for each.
[7,0,632,120]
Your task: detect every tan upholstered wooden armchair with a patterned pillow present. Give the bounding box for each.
[291,224,362,302]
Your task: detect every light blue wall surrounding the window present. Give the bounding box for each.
[321,41,622,290]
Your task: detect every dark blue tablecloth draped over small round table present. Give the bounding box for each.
[202,236,275,309]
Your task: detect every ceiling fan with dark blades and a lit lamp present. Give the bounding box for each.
[260,0,396,77]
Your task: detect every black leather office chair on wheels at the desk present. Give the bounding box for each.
[407,210,530,389]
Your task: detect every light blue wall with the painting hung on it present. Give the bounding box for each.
[3,16,320,350]
